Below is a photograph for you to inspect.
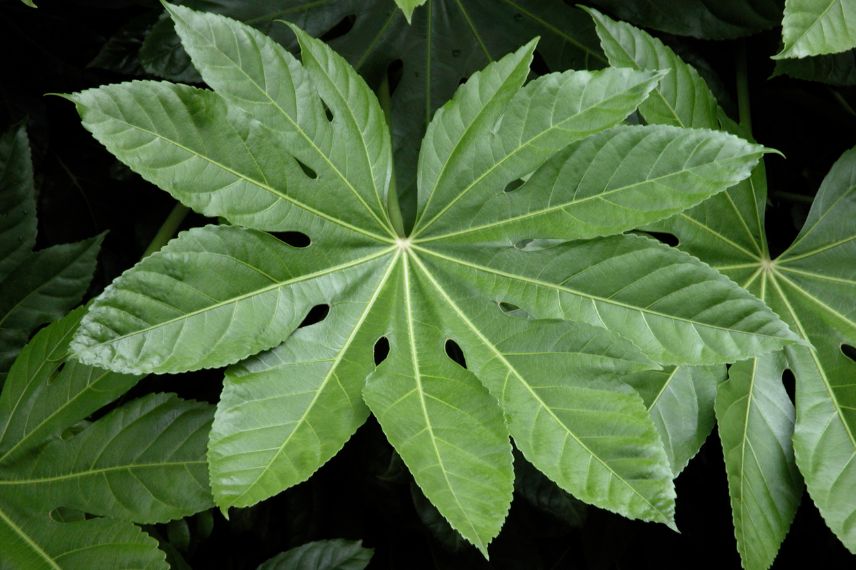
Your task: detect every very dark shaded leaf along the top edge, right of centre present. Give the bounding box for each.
[591,0,783,40]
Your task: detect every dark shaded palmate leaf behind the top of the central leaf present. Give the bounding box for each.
[134,0,605,222]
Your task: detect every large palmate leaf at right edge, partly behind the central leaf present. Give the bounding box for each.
[595,7,856,569]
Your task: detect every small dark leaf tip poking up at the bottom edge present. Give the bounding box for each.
[258,538,374,570]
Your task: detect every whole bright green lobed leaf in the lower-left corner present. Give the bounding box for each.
[0,308,212,569]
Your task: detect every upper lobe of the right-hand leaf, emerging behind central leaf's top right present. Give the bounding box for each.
[586,8,719,129]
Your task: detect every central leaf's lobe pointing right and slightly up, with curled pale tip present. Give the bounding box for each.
[423,126,764,243]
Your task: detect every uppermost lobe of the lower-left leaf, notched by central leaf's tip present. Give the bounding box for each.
[0,307,139,463]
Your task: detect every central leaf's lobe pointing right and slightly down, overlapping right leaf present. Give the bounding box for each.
[417,235,796,364]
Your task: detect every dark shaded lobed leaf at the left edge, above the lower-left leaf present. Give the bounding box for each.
[0,126,103,386]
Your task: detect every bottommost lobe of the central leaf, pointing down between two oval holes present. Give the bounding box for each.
[363,259,514,556]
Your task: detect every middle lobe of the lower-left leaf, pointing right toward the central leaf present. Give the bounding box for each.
[0,394,211,523]
